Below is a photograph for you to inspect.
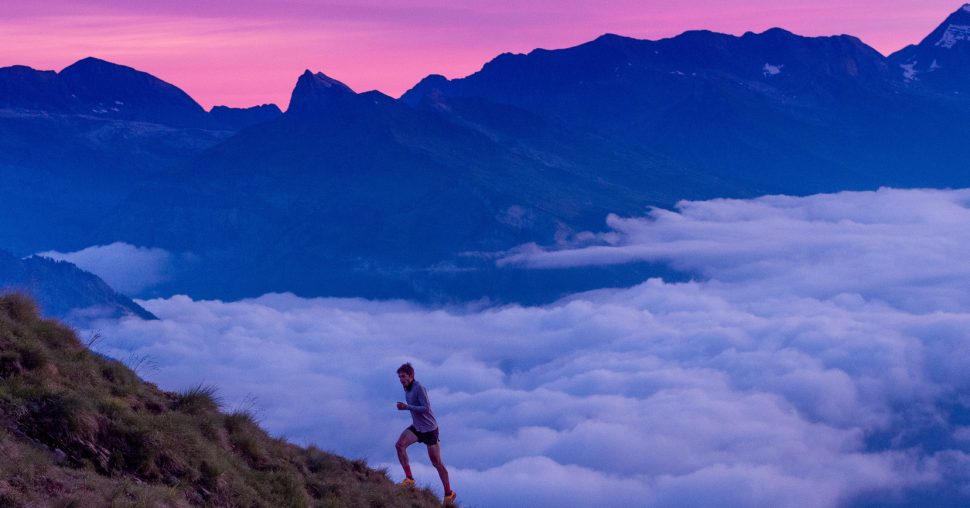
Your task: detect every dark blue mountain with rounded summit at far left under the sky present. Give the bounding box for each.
[0,58,262,255]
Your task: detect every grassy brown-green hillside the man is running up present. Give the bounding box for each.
[0,295,439,507]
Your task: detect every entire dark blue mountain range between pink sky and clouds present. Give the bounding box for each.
[0,5,970,301]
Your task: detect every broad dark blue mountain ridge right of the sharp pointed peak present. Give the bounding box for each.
[402,29,970,194]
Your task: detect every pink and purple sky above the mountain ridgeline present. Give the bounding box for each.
[0,0,960,108]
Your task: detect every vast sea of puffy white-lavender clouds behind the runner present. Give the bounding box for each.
[85,189,970,507]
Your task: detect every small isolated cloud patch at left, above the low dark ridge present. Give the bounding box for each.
[37,242,175,295]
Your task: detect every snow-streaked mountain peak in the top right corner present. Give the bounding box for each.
[889,4,970,94]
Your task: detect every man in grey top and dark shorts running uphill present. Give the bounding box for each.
[395,363,458,504]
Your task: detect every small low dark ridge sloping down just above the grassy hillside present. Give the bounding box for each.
[0,250,157,325]
